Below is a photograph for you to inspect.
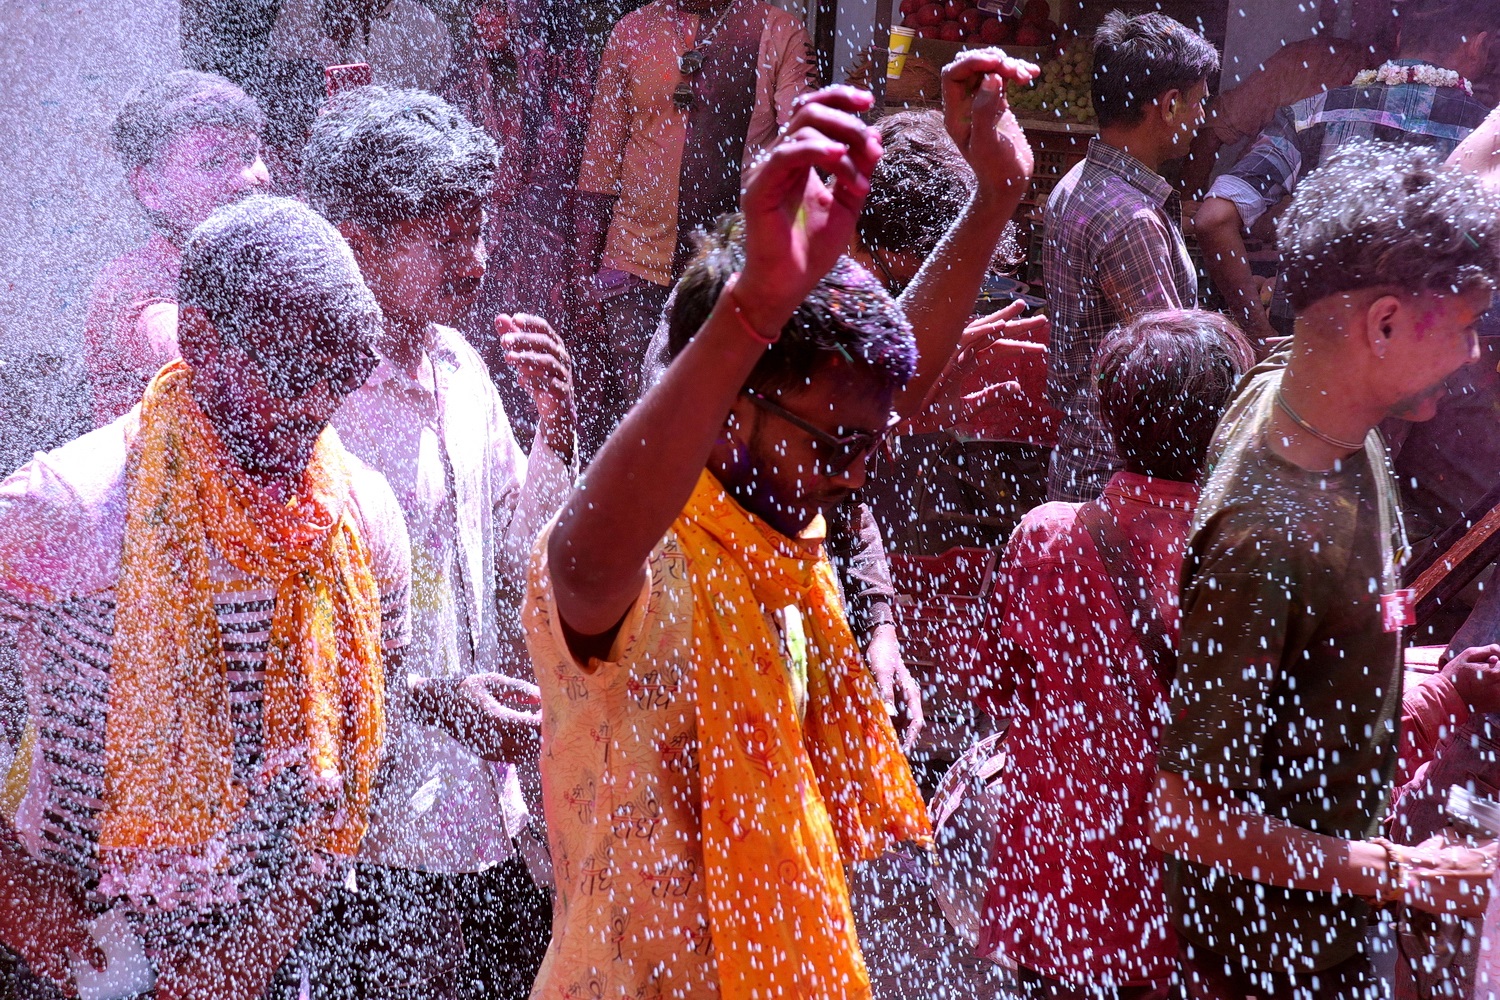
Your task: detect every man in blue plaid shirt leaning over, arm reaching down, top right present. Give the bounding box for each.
[1193,0,1500,340]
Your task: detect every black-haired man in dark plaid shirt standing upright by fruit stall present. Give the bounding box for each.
[1043,12,1218,501]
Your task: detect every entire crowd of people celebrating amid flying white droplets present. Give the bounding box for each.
[11,0,1500,1000]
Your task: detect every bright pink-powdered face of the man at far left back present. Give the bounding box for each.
[131,127,270,234]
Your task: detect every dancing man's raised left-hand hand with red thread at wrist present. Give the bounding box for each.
[735,87,881,333]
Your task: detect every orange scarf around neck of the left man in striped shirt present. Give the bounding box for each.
[99,361,386,868]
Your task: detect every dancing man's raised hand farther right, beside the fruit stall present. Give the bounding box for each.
[942,48,1041,209]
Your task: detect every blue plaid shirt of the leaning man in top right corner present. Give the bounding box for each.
[1209,66,1490,333]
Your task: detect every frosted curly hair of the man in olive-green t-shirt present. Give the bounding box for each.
[1277,141,1500,312]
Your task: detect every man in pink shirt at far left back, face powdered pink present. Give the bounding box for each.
[84,69,270,427]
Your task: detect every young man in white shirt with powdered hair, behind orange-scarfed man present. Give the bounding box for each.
[303,87,575,999]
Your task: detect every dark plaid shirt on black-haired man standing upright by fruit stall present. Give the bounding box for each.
[1043,139,1199,501]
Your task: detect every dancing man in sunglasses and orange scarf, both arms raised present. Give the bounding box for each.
[525,66,1034,997]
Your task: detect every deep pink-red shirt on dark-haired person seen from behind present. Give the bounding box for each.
[980,472,1197,985]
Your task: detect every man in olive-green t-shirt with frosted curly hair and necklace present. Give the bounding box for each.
[1152,142,1500,1000]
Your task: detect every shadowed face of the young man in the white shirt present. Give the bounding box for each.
[356,201,488,324]
